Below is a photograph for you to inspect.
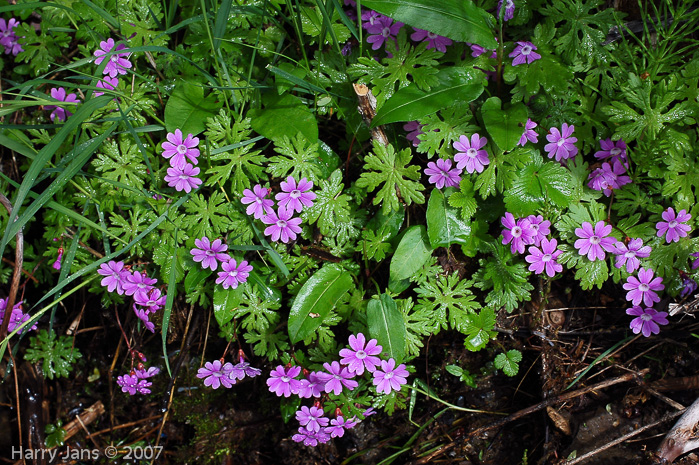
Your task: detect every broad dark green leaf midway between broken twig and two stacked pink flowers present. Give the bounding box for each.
[248,94,318,140]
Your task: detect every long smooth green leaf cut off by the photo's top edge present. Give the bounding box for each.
[362,0,498,49]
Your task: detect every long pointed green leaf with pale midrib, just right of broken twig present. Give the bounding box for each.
[371,68,484,126]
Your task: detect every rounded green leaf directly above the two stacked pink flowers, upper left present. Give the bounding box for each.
[165,82,223,137]
